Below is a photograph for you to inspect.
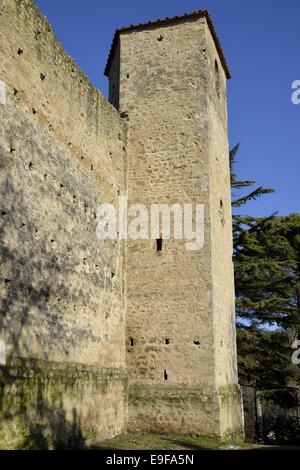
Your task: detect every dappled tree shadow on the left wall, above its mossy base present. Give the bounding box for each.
[0,121,90,359]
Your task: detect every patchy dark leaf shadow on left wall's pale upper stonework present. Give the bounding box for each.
[0,180,70,358]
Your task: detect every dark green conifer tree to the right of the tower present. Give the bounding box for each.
[230,145,300,407]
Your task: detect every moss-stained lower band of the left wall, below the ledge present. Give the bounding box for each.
[0,358,127,449]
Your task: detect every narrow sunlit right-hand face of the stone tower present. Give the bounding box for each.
[204,21,243,434]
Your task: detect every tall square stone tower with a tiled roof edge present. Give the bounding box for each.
[106,11,242,436]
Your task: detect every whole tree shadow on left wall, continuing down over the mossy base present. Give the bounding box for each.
[0,146,84,449]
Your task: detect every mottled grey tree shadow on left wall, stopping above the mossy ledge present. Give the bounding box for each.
[0,154,76,360]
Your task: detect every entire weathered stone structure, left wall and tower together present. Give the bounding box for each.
[0,0,242,448]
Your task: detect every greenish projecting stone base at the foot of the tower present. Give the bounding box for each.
[128,384,244,439]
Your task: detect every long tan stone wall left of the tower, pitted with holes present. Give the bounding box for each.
[0,0,126,446]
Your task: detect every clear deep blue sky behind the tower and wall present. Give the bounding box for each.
[36,0,300,216]
